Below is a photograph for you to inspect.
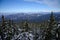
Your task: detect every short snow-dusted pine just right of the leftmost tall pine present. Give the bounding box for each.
[6,19,14,40]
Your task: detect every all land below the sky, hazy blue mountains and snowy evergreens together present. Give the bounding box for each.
[0,12,60,40]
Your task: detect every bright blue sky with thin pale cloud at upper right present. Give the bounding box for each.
[0,0,60,13]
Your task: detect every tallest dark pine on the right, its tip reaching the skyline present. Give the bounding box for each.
[45,12,56,40]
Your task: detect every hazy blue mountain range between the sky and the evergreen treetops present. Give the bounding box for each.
[0,12,60,22]
